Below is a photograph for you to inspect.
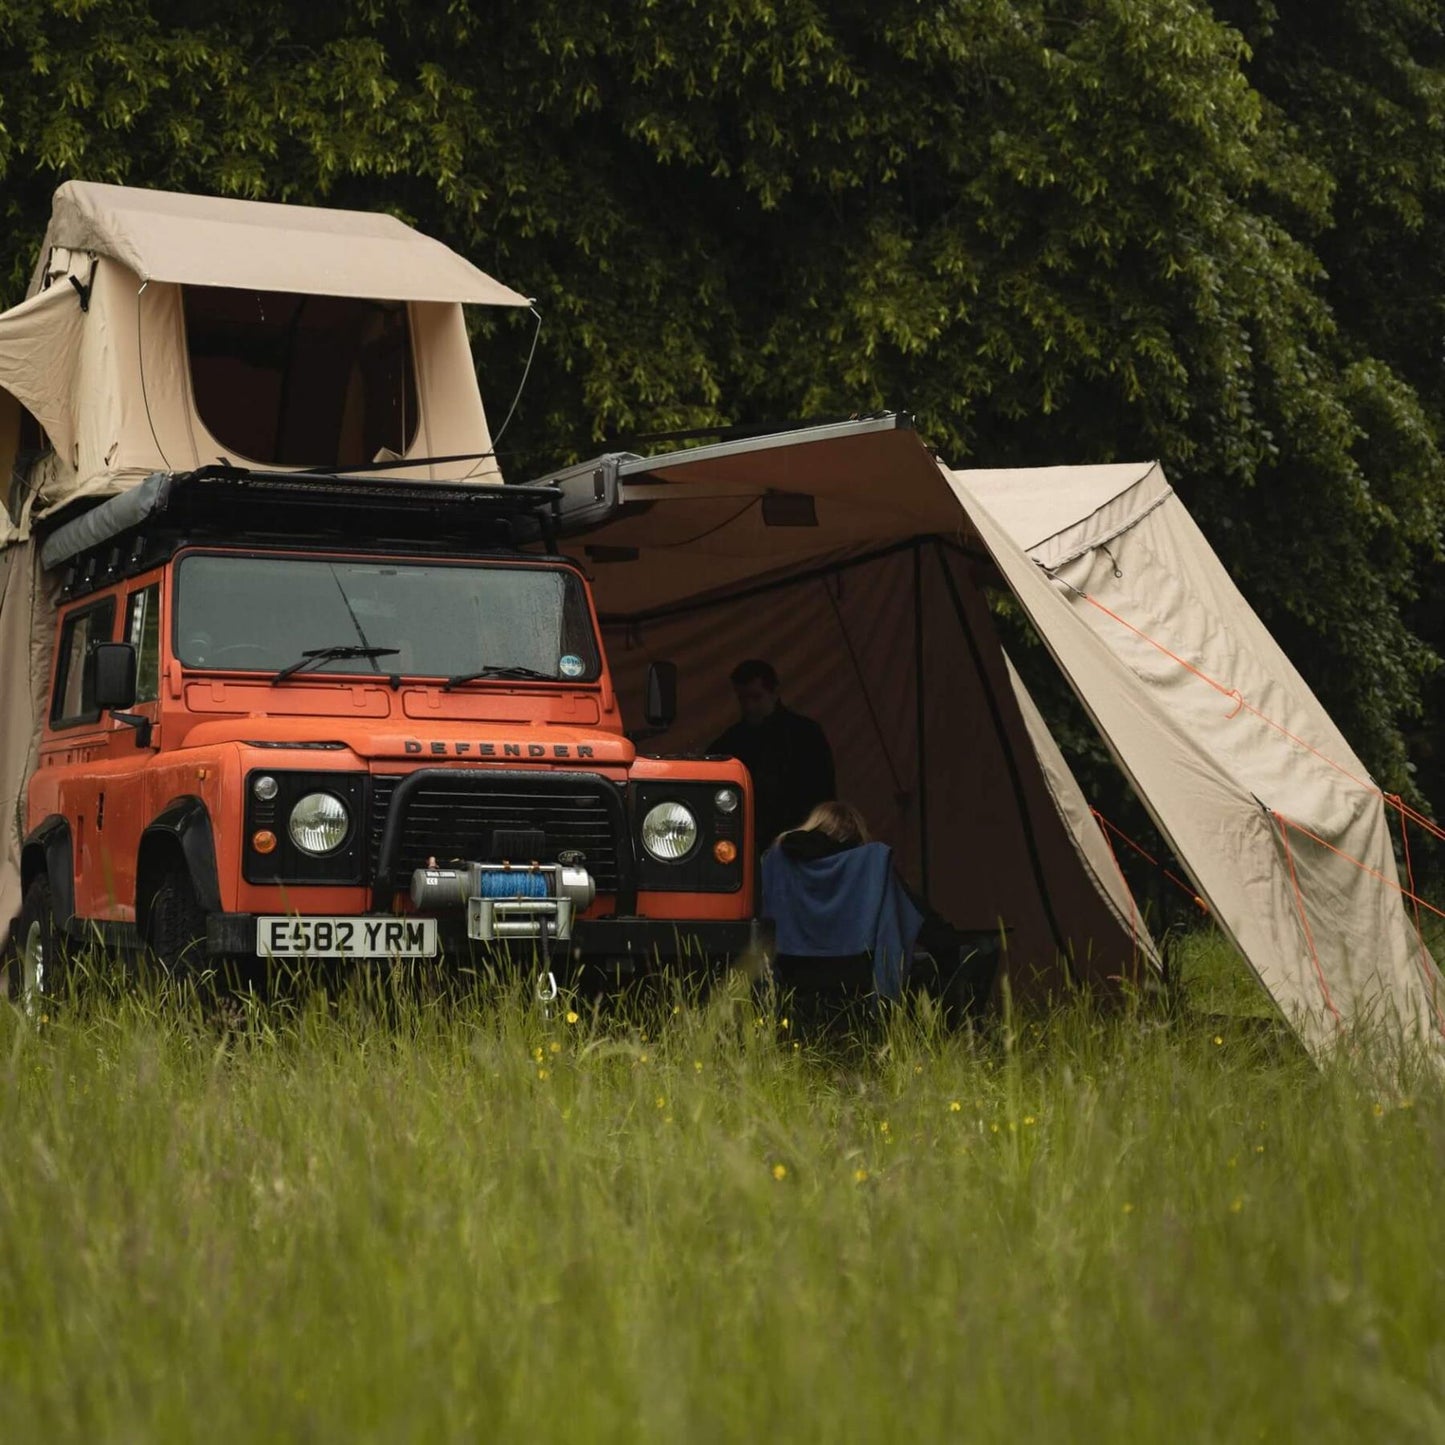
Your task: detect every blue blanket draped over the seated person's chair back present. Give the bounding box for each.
[763,842,923,998]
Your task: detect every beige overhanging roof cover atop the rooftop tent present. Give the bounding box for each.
[30,181,527,306]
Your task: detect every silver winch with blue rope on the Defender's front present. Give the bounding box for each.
[412,863,597,944]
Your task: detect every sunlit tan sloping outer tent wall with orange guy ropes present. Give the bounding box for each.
[946,468,1445,1052]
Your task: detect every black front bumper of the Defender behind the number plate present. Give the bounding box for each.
[205,913,767,967]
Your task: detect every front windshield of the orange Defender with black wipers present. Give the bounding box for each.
[175,553,600,682]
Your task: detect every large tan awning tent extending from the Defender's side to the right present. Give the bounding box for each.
[531,416,1445,1053]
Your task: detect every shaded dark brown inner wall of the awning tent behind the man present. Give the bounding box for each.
[598,537,1156,996]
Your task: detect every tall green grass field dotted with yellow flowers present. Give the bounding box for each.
[0,942,1445,1442]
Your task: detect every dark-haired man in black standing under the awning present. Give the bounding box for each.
[708,657,837,853]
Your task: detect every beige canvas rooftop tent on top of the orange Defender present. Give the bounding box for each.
[0,181,529,944]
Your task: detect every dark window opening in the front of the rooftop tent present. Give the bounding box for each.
[185,286,418,467]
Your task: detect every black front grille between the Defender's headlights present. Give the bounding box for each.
[368,769,621,893]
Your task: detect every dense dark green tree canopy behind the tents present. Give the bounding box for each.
[0,0,1445,785]
